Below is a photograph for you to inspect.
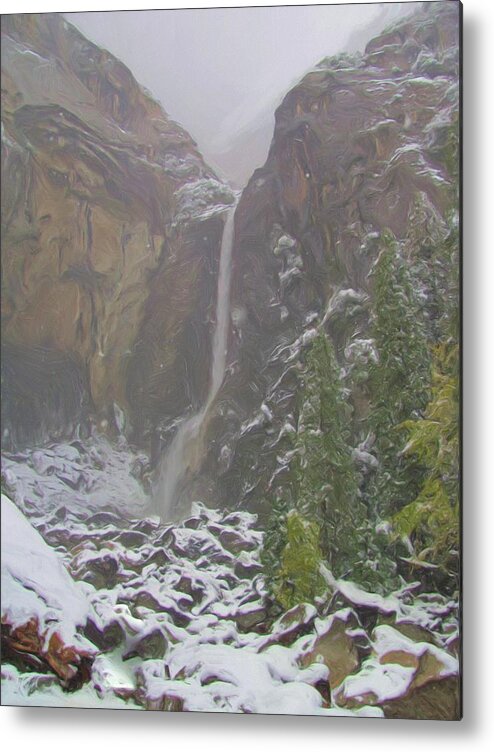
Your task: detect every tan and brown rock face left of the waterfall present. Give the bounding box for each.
[2,14,233,448]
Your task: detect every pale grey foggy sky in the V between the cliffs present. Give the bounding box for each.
[64,3,415,186]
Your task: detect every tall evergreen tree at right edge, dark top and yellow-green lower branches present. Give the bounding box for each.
[392,247,460,587]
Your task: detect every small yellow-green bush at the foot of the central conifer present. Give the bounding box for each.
[274,509,324,609]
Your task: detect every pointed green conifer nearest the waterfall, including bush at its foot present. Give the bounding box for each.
[262,331,365,603]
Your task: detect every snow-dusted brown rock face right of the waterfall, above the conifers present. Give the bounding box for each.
[191,3,459,510]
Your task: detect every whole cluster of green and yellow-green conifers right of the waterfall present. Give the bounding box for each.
[263,220,459,608]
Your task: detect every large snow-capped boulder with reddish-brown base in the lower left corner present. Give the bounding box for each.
[1,495,96,690]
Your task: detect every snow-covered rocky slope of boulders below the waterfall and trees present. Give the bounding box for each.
[2,446,459,720]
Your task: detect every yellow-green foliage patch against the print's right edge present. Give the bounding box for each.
[392,344,459,566]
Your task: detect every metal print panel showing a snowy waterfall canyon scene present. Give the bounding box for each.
[1,1,461,720]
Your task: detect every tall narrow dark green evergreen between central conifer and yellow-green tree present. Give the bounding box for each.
[367,231,430,517]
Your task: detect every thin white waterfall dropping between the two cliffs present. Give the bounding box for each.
[155,204,236,520]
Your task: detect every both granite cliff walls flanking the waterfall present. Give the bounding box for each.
[2,3,459,510]
